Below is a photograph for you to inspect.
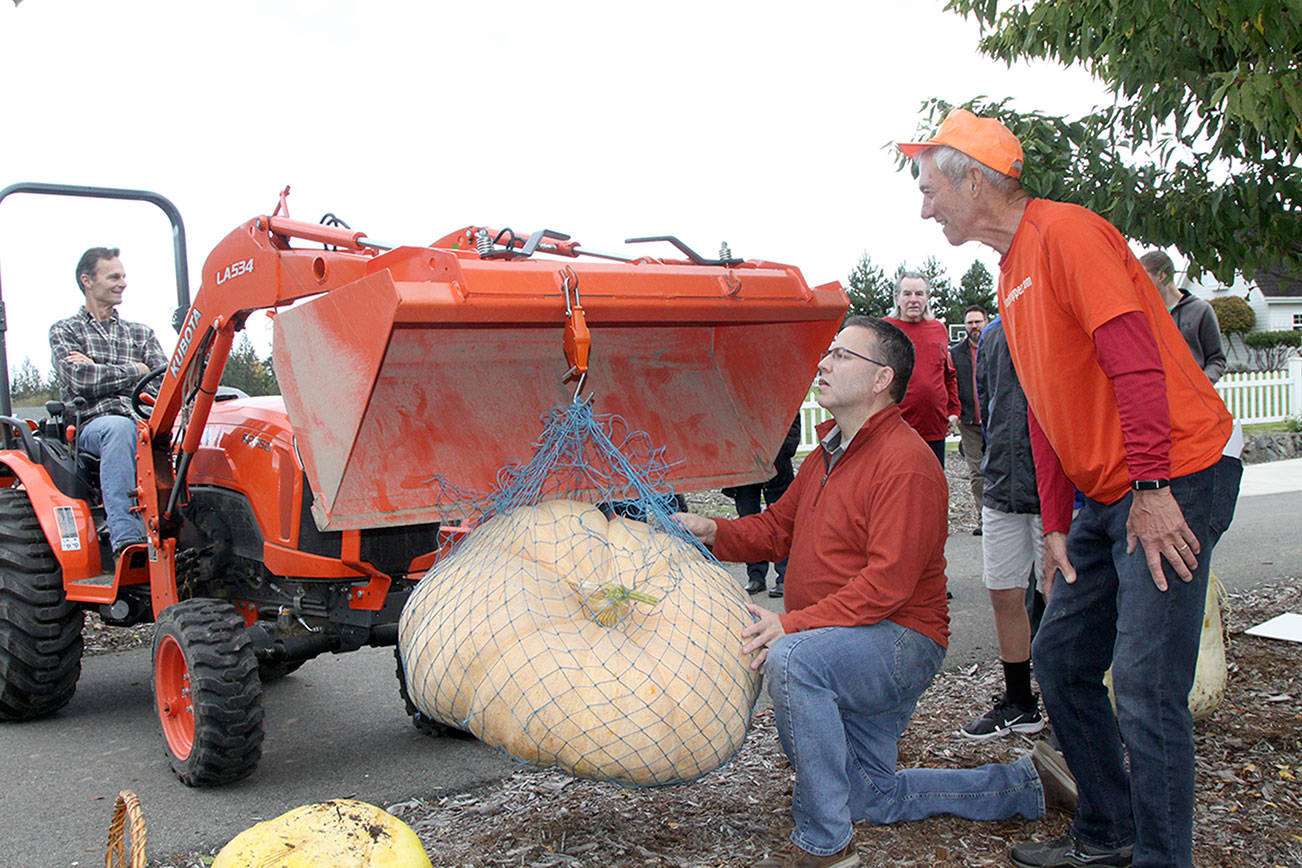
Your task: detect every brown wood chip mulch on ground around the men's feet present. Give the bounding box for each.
[388,578,1302,868]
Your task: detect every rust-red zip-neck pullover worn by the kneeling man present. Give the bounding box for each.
[713,406,949,647]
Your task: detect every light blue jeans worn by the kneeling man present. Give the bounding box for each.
[764,621,1044,856]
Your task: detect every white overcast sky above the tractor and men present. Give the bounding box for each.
[0,0,1107,368]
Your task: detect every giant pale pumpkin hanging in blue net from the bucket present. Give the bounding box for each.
[398,402,759,786]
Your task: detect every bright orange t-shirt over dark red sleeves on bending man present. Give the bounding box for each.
[999,199,1232,504]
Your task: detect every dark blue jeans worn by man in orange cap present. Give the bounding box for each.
[1031,458,1243,868]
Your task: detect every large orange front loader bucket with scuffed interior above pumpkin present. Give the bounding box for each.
[273,240,848,530]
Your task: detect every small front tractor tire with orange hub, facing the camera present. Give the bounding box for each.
[154,597,263,786]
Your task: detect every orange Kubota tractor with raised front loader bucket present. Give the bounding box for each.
[0,183,848,786]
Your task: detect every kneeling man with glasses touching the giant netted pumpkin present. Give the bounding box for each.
[678,316,1074,868]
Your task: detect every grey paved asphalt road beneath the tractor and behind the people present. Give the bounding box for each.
[0,461,1302,865]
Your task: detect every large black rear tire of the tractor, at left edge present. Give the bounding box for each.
[0,488,83,721]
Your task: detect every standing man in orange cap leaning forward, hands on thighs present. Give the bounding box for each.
[898,109,1242,867]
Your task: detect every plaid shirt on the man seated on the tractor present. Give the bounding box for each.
[49,307,167,420]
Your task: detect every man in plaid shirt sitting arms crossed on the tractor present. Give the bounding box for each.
[49,247,167,560]
